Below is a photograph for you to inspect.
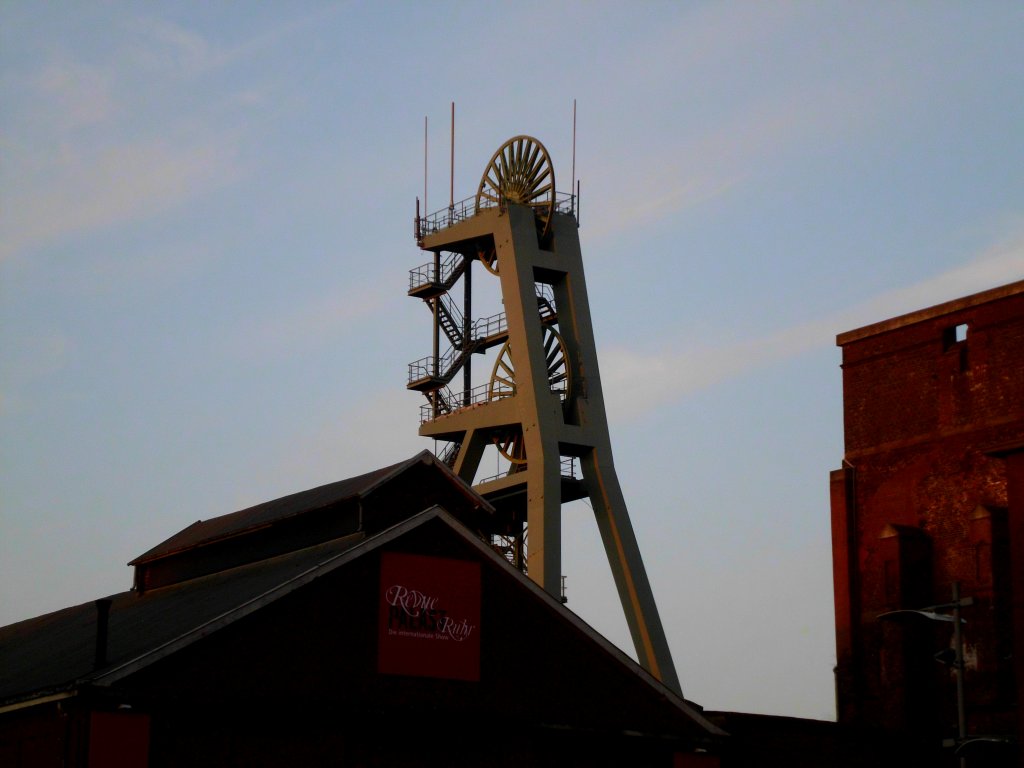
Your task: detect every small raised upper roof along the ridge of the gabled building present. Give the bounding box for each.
[128,451,489,565]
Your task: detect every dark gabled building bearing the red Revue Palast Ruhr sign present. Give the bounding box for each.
[0,452,723,768]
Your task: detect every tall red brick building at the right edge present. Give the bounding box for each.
[830,282,1024,761]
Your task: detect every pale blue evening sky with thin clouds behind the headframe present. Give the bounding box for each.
[0,0,1024,720]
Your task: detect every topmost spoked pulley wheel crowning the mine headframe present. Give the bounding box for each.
[476,136,555,240]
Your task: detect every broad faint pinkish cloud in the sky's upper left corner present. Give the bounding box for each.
[0,11,344,261]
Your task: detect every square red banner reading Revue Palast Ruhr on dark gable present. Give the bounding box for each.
[377,552,480,681]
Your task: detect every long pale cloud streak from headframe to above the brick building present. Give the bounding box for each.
[601,231,1024,420]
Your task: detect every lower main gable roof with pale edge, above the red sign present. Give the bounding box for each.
[0,507,723,736]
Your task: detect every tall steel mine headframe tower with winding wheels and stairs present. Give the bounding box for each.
[408,136,682,694]
